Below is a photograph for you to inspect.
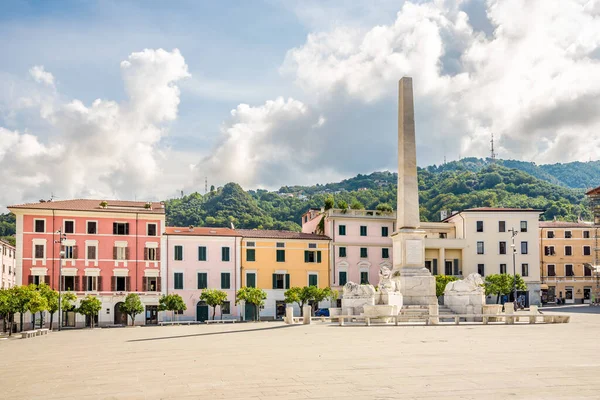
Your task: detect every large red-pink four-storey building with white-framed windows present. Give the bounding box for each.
[9,200,165,326]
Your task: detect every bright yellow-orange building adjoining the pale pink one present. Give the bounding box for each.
[237,229,330,319]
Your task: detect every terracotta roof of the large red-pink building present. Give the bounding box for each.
[8,199,165,214]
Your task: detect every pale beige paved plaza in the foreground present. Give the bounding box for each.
[0,307,600,400]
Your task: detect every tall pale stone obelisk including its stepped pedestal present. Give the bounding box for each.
[392,77,437,305]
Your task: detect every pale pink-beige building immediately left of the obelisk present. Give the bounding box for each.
[302,209,396,298]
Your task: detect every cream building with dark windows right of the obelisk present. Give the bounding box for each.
[444,207,542,305]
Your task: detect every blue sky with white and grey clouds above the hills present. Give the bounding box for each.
[0,0,600,209]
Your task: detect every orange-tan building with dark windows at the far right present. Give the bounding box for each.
[539,221,597,304]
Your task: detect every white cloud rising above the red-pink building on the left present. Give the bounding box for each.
[0,49,189,205]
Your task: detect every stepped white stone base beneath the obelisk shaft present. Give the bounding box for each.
[392,228,438,306]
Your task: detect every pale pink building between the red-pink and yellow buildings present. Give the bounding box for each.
[162,226,241,321]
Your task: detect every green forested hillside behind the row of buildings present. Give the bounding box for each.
[0,158,600,236]
